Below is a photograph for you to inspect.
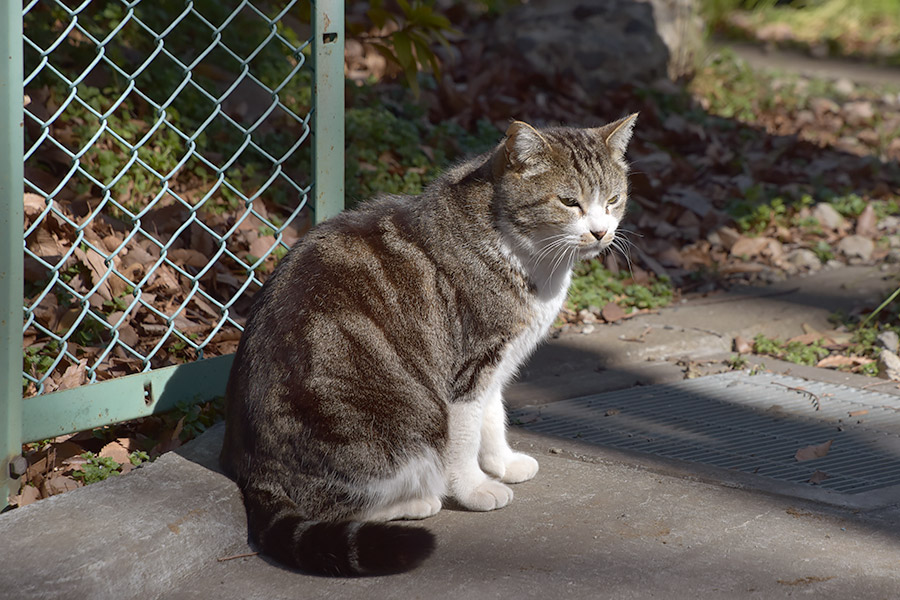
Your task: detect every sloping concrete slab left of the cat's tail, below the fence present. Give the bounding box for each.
[0,433,246,600]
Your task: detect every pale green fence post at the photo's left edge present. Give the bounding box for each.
[0,2,25,509]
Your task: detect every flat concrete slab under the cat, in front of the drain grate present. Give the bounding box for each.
[165,432,900,600]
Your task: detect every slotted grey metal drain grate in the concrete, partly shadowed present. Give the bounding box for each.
[510,372,900,494]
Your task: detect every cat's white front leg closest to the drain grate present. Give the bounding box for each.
[478,390,538,483]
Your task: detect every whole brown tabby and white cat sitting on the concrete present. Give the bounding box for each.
[220,114,637,575]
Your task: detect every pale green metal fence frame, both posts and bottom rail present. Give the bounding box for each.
[0,0,344,509]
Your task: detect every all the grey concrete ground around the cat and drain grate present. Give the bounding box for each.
[0,267,900,600]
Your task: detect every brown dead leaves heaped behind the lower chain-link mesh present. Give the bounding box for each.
[23,155,310,396]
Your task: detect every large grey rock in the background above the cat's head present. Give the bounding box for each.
[479,0,703,98]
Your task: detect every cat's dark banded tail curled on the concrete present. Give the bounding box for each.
[244,487,435,576]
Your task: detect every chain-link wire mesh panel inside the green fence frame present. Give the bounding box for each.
[23,0,312,396]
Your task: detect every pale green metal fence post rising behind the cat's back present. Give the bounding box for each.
[312,0,344,223]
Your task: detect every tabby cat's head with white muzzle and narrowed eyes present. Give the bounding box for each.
[493,114,637,263]
